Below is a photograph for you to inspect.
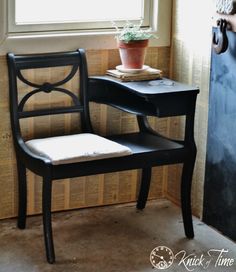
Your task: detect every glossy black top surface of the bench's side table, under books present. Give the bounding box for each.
[90,76,199,96]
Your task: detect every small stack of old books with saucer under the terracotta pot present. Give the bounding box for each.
[106,67,162,81]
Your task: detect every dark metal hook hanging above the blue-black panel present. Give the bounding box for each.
[212,19,229,54]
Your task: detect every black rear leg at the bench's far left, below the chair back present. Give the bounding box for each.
[17,160,27,229]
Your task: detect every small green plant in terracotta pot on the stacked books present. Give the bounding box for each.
[113,22,155,69]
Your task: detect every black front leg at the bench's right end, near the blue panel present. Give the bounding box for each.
[181,156,196,238]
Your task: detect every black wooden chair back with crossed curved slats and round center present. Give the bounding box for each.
[7,49,92,146]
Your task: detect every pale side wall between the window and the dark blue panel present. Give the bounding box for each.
[170,0,213,217]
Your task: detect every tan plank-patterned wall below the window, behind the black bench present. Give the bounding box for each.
[0,47,171,219]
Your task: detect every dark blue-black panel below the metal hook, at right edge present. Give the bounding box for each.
[203,28,236,240]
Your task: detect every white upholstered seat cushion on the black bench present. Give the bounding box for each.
[26,133,132,165]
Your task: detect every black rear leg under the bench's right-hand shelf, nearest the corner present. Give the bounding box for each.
[136,167,152,210]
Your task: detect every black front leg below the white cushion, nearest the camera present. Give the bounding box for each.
[42,178,55,264]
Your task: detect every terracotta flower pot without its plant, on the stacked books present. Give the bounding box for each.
[118,40,148,69]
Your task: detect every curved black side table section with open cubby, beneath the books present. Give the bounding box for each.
[89,76,199,117]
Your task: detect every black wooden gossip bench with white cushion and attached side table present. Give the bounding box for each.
[7,49,199,263]
